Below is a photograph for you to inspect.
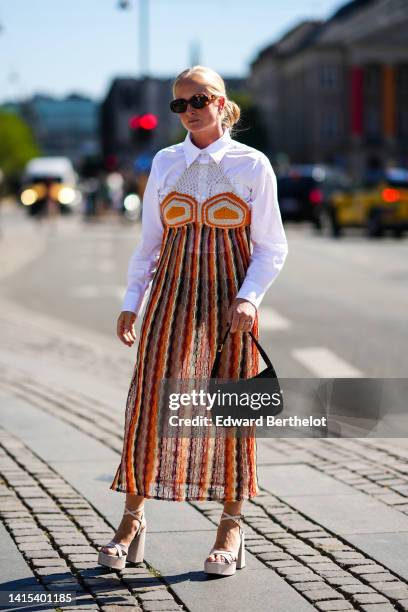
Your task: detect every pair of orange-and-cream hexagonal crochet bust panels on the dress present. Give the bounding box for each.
[160,191,251,228]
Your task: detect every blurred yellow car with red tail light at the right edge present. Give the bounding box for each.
[322,168,408,237]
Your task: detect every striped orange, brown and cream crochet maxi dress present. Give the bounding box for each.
[110,158,259,502]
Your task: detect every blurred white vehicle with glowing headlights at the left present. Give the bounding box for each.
[20,156,81,216]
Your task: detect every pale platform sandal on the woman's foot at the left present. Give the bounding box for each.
[98,506,147,569]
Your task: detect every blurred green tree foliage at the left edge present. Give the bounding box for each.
[0,110,40,184]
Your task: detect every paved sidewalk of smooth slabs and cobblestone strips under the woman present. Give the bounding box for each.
[0,299,408,612]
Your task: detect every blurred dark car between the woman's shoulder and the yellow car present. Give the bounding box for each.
[277,164,349,230]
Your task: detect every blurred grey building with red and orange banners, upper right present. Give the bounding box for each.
[250,0,408,177]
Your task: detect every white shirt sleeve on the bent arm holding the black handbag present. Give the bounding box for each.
[236,155,288,309]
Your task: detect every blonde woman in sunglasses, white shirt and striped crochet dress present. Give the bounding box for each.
[99,66,287,575]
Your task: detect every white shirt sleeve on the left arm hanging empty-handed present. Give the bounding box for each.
[122,155,164,314]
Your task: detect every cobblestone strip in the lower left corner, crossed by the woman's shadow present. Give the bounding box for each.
[0,429,185,612]
